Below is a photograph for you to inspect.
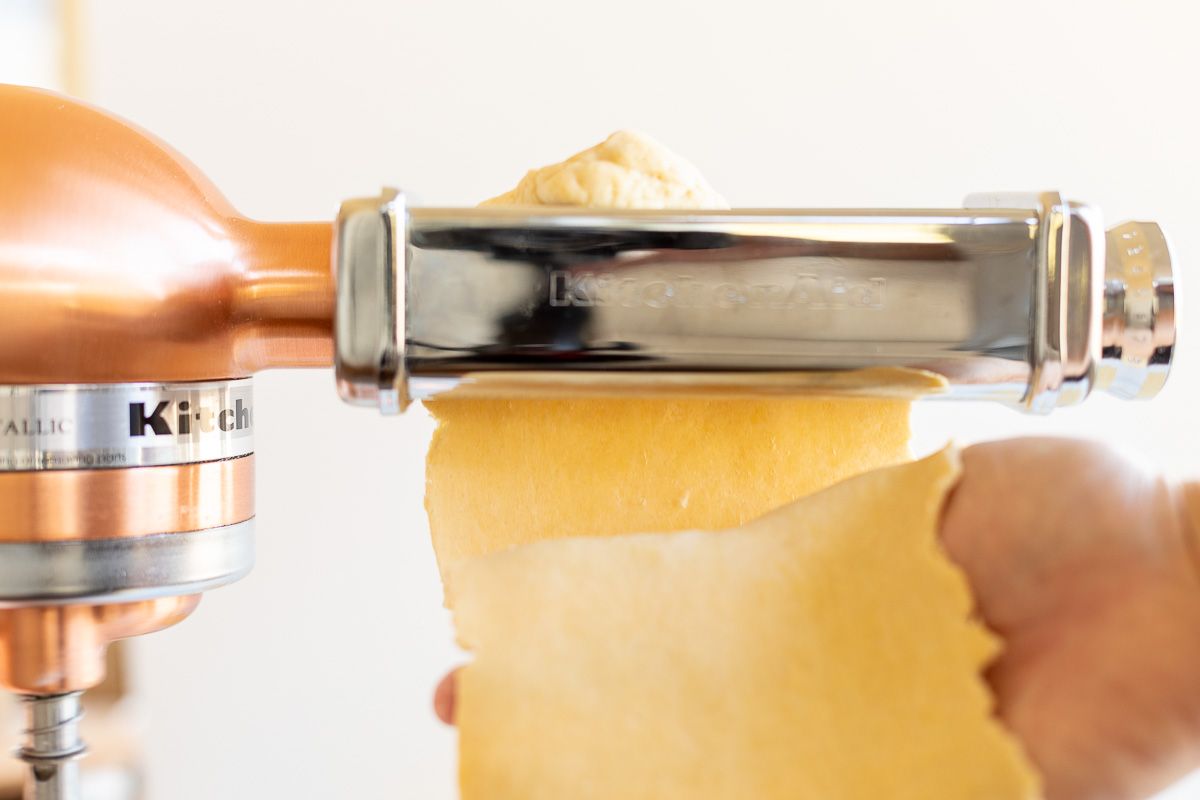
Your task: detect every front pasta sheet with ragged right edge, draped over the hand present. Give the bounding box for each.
[448,452,1037,800]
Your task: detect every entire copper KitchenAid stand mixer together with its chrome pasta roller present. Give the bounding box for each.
[0,86,1175,800]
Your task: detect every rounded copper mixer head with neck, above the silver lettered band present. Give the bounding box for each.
[0,86,334,384]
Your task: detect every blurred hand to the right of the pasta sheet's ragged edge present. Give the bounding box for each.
[941,439,1200,800]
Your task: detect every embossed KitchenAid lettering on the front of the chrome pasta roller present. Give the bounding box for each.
[550,270,884,311]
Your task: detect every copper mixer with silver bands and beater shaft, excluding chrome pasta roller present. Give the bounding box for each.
[0,86,334,798]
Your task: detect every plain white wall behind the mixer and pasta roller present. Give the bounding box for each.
[7,0,1200,800]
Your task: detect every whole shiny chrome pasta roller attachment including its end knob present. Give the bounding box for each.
[335,191,1175,413]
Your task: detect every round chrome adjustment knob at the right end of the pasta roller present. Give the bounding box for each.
[1097,222,1175,399]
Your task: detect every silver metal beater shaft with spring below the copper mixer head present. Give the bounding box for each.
[17,692,86,800]
